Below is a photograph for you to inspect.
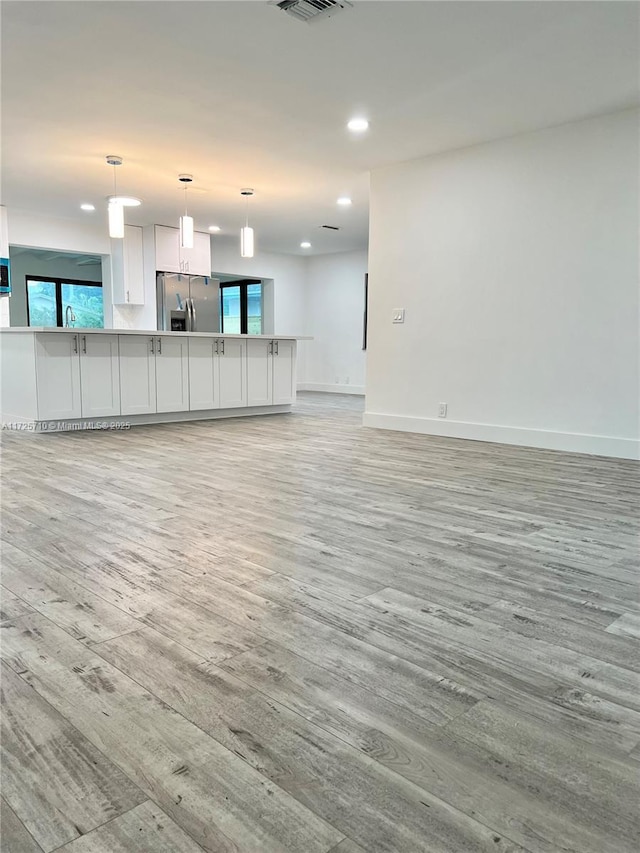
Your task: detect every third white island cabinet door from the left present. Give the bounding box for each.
[118,335,157,415]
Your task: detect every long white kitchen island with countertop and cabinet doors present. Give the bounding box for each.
[0,327,304,432]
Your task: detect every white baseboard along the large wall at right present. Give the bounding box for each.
[362,412,640,459]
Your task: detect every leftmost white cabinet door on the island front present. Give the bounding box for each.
[36,332,82,421]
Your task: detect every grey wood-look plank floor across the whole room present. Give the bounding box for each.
[0,394,640,853]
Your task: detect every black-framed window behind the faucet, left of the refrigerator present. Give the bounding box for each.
[26,275,104,329]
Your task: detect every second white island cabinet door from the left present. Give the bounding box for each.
[79,334,120,418]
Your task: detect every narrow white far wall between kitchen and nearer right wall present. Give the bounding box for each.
[301,246,367,394]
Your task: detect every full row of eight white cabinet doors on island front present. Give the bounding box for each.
[35,330,296,421]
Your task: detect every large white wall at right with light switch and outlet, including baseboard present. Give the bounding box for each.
[365,111,639,457]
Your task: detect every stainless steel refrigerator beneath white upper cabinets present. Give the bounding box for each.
[156,272,220,332]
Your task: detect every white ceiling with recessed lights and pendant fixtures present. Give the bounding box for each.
[2,0,638,254]
